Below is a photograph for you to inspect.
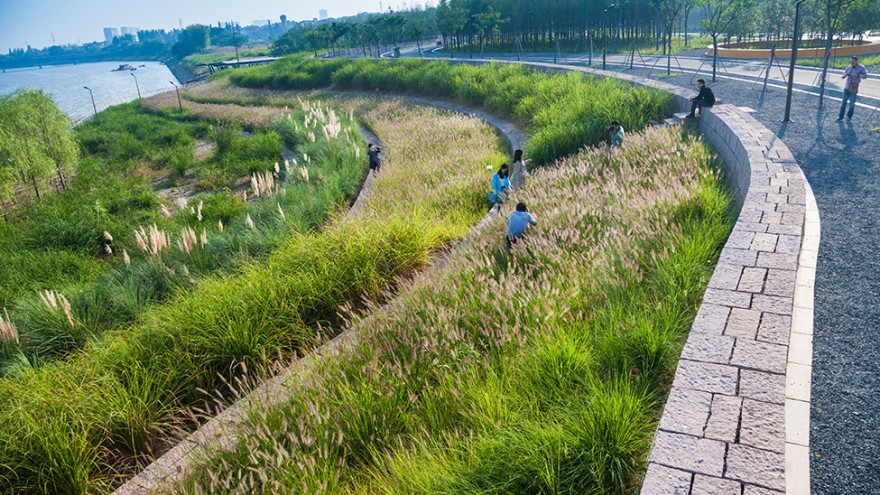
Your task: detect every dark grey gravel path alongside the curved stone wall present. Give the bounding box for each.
[633,67,880,495]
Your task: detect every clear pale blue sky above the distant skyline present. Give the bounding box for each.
[0,0,402,55]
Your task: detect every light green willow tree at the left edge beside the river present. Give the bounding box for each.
[0,90,79,201]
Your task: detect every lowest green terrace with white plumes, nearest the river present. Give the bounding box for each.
[0,96,363,374]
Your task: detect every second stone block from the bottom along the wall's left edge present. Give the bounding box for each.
[650,430,726,476]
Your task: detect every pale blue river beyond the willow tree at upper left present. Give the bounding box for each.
[0,61,178,121]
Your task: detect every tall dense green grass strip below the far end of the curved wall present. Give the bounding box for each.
[230,57,671,165]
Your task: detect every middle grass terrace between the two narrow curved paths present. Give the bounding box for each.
[0,92,503,493]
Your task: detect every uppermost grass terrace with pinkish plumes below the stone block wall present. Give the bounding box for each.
[156,61,731,494]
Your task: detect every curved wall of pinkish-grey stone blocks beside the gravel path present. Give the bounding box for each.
[440,60,819,495]
